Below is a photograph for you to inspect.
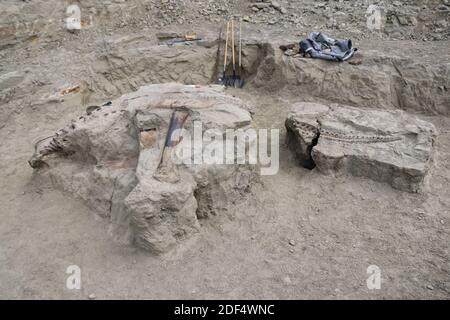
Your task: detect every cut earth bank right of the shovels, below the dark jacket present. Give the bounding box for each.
[248,44,450,115]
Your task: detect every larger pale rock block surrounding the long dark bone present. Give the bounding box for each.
[30,83,255,253]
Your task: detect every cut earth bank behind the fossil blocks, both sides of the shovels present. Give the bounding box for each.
[88,40,450,115]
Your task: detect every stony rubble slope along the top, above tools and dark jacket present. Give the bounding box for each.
[0,0,450,57]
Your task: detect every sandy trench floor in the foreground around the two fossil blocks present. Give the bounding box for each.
[0,85,450,299]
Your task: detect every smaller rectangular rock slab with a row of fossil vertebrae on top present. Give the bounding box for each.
[286,103,436,192]
